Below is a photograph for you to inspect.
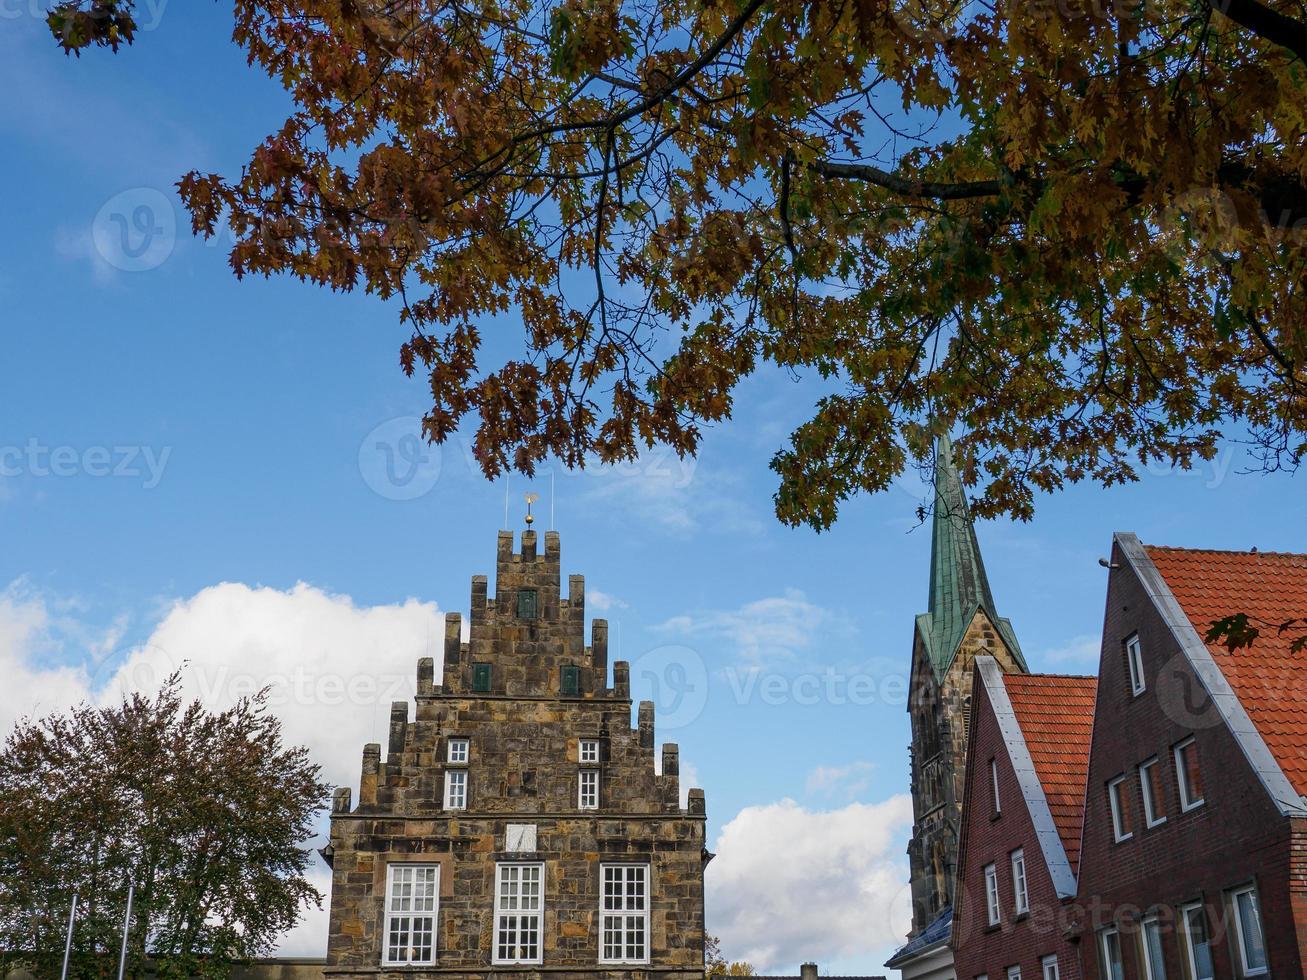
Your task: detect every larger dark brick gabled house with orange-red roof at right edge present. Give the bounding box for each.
[1078,533,1307,980]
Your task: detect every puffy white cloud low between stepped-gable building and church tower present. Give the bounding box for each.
[707,796,912,972]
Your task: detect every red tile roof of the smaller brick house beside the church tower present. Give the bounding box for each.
[1002,674,1098,869]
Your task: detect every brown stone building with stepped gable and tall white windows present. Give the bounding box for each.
[324,531,711,980]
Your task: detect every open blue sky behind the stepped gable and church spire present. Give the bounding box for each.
[0,0,1307,972]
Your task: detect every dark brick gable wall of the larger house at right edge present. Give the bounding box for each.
[1078,536,1307,980]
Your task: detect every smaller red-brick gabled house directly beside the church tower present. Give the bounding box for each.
[951,657,1097,980]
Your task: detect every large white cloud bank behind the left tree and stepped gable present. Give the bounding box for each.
[0,583,444,956]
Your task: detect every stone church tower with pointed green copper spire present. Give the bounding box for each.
[887,436,1026,976]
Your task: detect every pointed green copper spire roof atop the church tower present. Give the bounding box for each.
[916,435,1026,677]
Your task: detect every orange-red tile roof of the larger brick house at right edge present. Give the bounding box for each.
[1145,546,1307,794]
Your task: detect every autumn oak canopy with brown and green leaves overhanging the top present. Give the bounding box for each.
[50,0,1307,528]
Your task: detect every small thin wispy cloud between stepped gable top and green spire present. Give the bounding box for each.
[655,589,850,666]
